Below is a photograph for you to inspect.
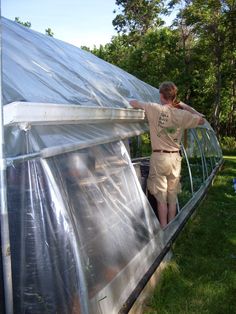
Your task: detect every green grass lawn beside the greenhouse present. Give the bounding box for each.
[145,156,236,314]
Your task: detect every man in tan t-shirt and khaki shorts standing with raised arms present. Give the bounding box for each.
[130,82,205,228]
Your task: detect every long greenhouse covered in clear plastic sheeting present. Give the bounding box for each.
[0,18,222,314]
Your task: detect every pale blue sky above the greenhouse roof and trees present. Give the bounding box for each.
[1,0,175,48]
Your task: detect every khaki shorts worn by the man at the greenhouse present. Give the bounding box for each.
[147,152,182,204]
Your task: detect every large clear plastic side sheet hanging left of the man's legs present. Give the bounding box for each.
[7,142,163,314]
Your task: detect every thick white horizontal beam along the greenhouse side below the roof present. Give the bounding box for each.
[3,102,144,125]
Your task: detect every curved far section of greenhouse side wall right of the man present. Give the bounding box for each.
[178,125,222,209]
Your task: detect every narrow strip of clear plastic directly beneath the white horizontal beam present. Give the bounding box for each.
[5,121,148,160]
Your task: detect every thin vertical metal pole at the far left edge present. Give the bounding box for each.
[0,7,13,314]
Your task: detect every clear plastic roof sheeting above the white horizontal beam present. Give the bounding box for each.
[1,18,159,108]
